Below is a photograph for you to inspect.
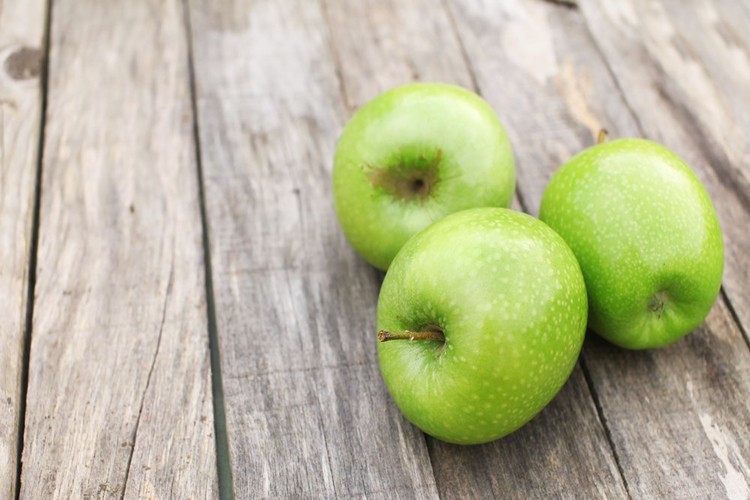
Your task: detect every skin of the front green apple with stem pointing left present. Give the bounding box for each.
[378,208,587,444]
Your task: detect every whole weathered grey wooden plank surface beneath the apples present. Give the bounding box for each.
[0,0,750,499]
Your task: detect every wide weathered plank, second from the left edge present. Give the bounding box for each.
[21,0,216,498]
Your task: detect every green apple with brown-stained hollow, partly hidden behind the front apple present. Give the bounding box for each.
[333,83,515,270]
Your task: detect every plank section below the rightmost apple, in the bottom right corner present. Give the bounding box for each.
[585,301,750,499]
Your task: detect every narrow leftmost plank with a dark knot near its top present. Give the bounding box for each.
[0,0,45,498]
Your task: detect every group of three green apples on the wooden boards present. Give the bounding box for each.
[333,84,724,444]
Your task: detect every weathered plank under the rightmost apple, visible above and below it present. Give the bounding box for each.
[446,0,750,498]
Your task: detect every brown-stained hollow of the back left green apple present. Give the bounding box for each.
[367,149,443,201]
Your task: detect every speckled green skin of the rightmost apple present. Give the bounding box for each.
[540,139,724,349]
